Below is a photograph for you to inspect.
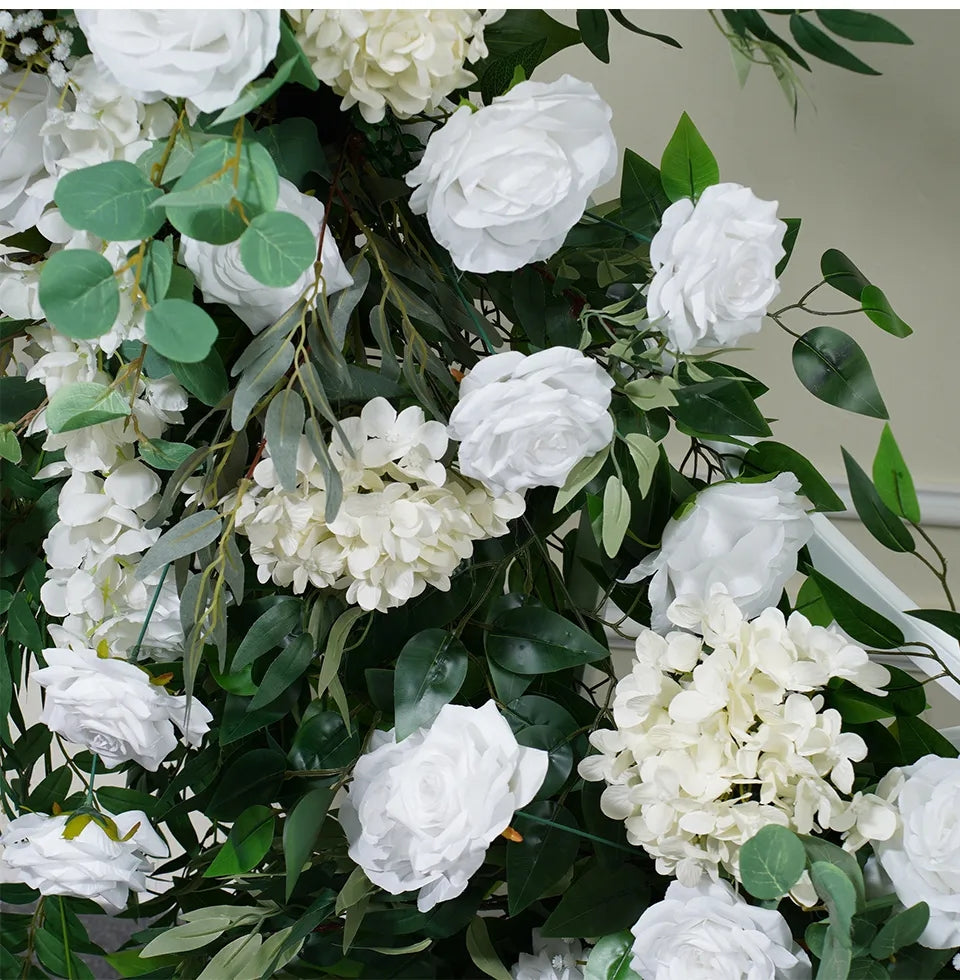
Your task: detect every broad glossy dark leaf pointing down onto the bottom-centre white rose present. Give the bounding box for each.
[393,629,468,742]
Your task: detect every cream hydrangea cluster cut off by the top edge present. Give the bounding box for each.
[287,10,503,123]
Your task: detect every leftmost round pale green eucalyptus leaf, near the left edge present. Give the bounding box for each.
[39,248,120,340]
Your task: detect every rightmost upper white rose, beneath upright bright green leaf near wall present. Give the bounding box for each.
[647,184,787,353]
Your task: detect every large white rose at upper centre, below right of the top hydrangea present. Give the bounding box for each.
[407,75,617,272]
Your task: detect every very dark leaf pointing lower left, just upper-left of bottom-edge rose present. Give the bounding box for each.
[541,863,649,938]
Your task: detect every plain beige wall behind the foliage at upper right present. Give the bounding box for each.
[537,10,960,605]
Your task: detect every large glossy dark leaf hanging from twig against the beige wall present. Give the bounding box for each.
[793,327,889,419]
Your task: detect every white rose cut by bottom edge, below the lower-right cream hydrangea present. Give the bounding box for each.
[631,879,811,980]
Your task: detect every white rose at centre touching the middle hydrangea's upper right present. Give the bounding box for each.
[448,347,613,493]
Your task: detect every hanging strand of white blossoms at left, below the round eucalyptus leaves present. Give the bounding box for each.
[9,327,187,656]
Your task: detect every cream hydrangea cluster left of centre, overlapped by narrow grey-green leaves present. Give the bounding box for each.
[238,398,525,612]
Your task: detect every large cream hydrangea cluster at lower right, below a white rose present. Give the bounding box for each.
[580,592,896,888]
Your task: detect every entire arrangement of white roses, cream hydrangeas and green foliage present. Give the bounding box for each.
[0,10,960,980]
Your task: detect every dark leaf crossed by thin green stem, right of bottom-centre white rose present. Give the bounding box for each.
[507,802,579,915]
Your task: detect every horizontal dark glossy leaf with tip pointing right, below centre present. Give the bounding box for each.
[487,606,610,674]
